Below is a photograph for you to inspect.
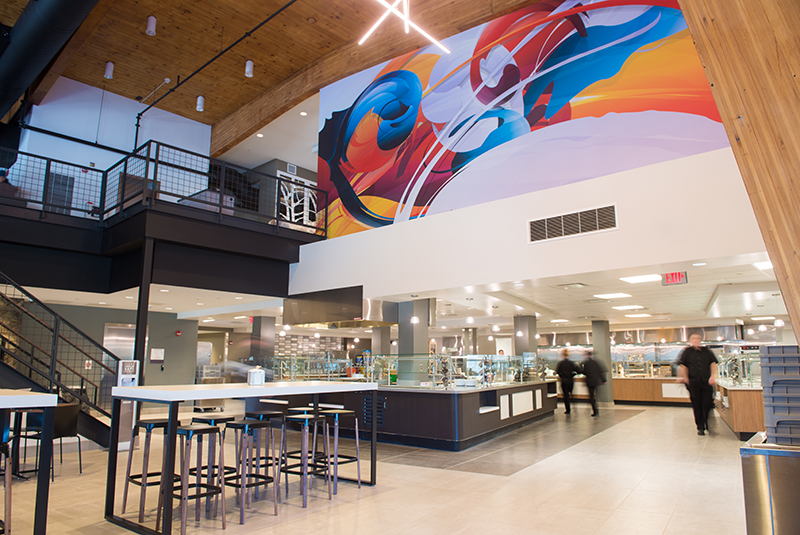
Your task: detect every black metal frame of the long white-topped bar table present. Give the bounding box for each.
[105,389,378,535]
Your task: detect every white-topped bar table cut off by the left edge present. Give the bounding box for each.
[0,388,58,535]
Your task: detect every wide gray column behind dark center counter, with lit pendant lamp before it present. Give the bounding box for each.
[397,299,430,385]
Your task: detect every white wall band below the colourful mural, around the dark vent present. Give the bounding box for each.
[289,148,766,298]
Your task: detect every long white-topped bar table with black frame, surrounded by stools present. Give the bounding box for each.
[106,381,378,535]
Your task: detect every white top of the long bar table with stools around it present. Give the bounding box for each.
[111,381,378,401]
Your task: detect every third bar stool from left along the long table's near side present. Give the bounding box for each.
[225,420,278,524]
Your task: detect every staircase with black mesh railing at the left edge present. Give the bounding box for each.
[0,273,120,447]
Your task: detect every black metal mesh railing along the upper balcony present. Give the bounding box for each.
[0,140,328,236]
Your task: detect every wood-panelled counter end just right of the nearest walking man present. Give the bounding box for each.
[716,382,766,440]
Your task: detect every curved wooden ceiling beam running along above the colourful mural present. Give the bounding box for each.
[211,0,539,158]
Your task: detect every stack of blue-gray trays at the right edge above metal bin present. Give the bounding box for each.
[761,346,800,445]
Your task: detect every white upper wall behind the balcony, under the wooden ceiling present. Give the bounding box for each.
[20,77,211,169]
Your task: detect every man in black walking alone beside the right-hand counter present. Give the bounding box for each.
[678,333,717,435]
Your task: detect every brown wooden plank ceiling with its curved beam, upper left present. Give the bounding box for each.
[23,0,537,155]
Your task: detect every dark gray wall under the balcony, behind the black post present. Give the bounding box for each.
[48,304,197,385]
